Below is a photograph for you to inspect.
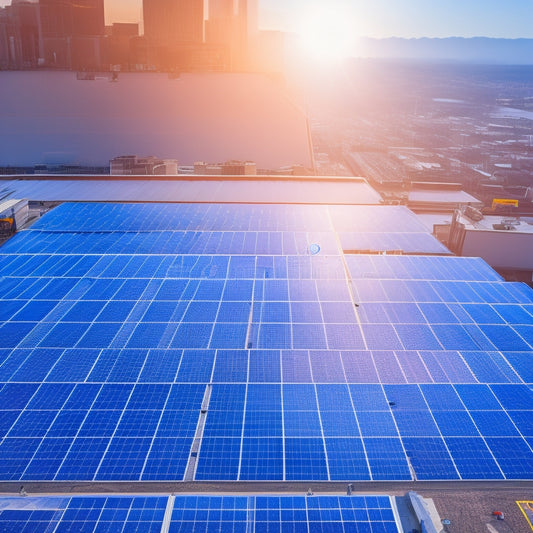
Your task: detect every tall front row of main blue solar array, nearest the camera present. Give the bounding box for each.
[0,384,533,481]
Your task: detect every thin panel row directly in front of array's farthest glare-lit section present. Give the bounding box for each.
[0,255,498,286]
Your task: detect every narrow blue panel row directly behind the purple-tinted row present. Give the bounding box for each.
[0,314,533,351]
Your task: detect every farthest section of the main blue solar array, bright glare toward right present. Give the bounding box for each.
[3,204,449,256]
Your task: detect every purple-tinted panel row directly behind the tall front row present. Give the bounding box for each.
[0,348,533,383]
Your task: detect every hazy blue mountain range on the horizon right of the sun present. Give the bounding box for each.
[357,37,533,65]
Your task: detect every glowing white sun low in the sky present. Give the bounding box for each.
[297,5,355,62]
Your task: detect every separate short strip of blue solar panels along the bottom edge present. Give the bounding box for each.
[0,495,399,533]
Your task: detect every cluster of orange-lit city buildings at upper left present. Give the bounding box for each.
[0,0,283,74]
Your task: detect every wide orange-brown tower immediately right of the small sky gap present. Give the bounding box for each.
[143,0,204,45]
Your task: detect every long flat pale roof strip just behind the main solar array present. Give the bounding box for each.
[0,176,382,205]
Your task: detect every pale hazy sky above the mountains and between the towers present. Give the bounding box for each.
[0,0,533,38]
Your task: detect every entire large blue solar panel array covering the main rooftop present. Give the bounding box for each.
[0,204,533,481]
